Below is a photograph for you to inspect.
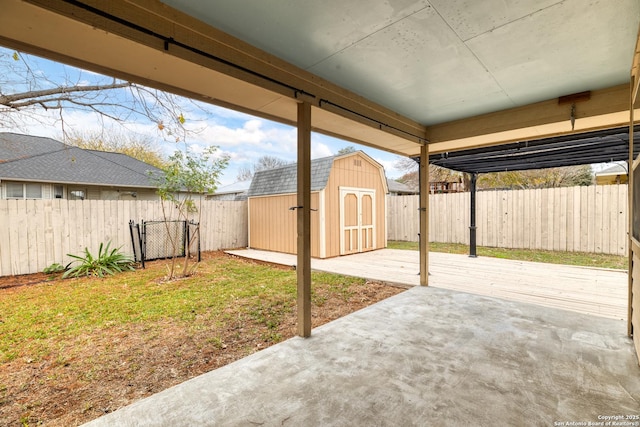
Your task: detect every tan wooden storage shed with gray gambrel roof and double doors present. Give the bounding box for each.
[248,151,388,258]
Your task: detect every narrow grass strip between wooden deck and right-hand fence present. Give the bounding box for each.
[387,241,629,270]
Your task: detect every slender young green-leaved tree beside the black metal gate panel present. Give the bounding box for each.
[157,147,229,280]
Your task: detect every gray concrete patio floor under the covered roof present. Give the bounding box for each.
[87,287,640,427]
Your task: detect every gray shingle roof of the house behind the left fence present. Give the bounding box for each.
[0,133,162,188]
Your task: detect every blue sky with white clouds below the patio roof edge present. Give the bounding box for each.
[0,47,405,187]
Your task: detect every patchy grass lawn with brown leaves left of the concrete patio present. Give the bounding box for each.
[0,253,402,426]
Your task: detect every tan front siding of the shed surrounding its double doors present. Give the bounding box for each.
[325,154,387,257]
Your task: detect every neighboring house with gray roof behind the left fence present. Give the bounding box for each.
[0,133,162,200]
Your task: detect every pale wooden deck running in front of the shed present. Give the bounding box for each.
[228,249,628,320]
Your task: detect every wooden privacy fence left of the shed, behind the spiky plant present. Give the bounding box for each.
[0,199,247,276]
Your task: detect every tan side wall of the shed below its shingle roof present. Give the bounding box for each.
[249,192,320,258]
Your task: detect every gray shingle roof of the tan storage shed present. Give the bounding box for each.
[248,156,337,197]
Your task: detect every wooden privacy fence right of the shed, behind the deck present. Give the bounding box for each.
[387,184,628,255]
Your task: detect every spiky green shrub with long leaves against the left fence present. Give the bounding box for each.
[62,242,134,278]
